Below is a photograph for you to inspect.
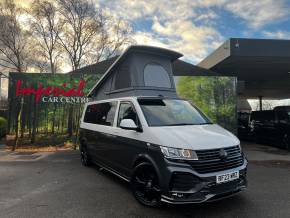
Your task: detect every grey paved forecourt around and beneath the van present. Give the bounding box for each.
[0,144,290,218]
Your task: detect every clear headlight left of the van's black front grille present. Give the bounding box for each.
[160,146,198,160]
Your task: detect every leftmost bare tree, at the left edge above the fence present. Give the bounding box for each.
[0,0,30,72]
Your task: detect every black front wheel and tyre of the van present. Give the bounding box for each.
[131,163,161,207]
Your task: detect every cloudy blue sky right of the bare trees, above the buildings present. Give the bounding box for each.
[95,0,290,63]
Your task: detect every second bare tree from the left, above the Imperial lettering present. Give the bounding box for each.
[29,0,63,74]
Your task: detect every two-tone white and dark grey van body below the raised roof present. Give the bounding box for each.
[80,97,247,206]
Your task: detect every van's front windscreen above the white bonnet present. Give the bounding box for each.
[138,98,212,126]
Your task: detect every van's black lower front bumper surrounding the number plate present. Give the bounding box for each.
[161,160,247,204]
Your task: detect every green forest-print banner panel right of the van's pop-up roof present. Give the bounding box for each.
[177,76,236,132]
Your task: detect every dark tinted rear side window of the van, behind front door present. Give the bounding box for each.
[84,102,117,126]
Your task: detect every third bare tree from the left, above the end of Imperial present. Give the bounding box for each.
[57,0,101,70]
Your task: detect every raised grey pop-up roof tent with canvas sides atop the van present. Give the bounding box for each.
[88,45,182,100]
